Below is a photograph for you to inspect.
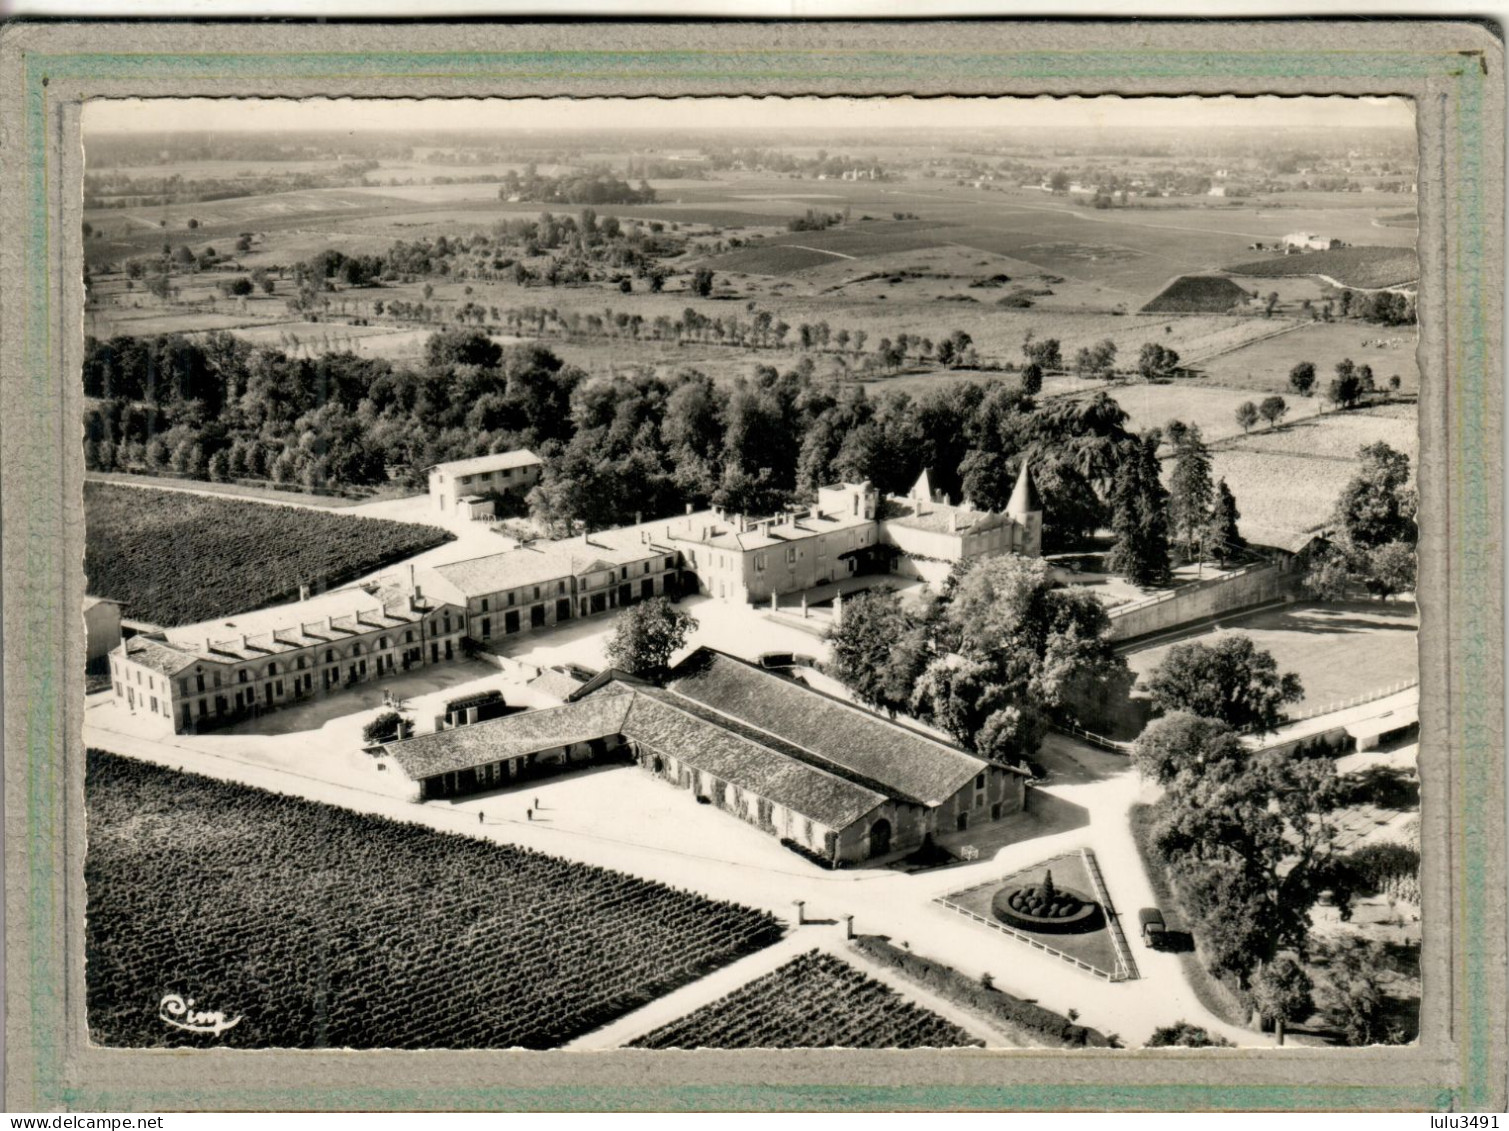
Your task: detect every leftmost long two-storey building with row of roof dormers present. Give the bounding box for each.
[110,582,466,734]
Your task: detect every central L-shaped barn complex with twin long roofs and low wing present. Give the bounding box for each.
[385,648,1028,863]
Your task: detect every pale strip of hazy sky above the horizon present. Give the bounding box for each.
[83,97,1414,133]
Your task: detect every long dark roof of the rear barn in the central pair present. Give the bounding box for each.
[668,648,988,805]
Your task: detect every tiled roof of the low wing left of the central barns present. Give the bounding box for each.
[386,689,632,781]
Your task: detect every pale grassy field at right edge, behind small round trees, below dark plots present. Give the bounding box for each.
[1200,323,1420,394]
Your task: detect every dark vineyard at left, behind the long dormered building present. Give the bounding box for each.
[85,483,454,627]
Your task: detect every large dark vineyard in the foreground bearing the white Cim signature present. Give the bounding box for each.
[85,749,782,1050]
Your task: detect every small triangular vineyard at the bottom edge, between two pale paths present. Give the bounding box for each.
[631,950,982,1048]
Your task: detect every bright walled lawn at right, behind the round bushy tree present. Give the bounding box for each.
[1126,602,1420,712]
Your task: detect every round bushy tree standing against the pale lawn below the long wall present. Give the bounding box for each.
[1147,632,1304,731]
